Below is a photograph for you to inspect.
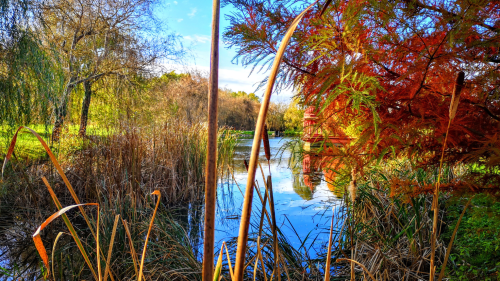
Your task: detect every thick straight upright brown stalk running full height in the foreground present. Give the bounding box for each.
[202,0,220,281]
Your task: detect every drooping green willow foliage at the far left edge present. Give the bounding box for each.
[0,0,63,127]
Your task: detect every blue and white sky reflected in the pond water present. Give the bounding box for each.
[215,138,341,255]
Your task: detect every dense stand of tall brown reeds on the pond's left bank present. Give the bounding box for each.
[3,120,237,205]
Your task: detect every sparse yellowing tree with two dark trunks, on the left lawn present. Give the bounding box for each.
[35,0,184,140]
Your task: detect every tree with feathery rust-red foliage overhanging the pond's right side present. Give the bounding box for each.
[224,0,500,187]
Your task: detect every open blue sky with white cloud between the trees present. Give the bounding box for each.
[156,0,292,102]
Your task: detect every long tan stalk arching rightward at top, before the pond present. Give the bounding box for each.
[233,1,317,281]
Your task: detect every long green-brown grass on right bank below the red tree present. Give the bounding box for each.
[336,164,454,280]
